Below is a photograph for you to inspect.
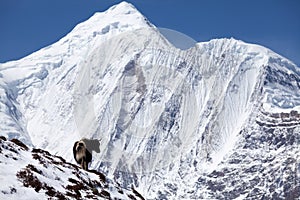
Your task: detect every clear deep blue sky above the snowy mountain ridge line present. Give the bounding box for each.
[0,0,300,66]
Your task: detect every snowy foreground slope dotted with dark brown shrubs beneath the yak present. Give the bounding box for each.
[0,137,144,200]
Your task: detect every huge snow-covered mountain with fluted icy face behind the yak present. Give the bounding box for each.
[0,2,300,199]
